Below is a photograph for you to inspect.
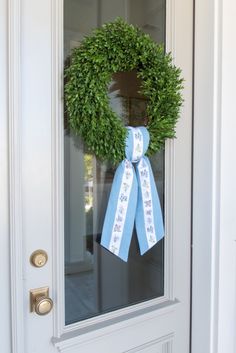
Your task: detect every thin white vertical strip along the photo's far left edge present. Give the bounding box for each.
[0,1,11,353]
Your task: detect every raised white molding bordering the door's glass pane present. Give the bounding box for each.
[51,0,181,338]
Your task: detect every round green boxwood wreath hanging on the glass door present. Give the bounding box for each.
[65,18,183,163]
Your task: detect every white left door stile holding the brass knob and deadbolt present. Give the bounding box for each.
[21,0,55,353]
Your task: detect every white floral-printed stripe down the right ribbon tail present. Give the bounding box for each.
[138,159,157,249]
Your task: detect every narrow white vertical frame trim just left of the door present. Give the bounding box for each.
[8,0,25,353]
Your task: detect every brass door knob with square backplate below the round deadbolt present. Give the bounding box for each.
[30,287,53,315]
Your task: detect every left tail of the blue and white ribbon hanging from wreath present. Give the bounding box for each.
[101,160,138,261]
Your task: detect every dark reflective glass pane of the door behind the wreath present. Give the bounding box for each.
[64,0,165,325]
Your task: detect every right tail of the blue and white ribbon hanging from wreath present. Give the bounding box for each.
[135,157,164,255]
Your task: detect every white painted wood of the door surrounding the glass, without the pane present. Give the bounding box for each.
[6,0,192,353]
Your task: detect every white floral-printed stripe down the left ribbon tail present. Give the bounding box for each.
[109,159,134,255]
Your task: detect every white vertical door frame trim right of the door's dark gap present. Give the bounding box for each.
[192,0,222,353]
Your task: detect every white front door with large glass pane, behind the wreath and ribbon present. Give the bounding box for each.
[10,0,193,353]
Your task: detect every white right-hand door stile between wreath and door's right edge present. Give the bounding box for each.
[167,1,193,352]
